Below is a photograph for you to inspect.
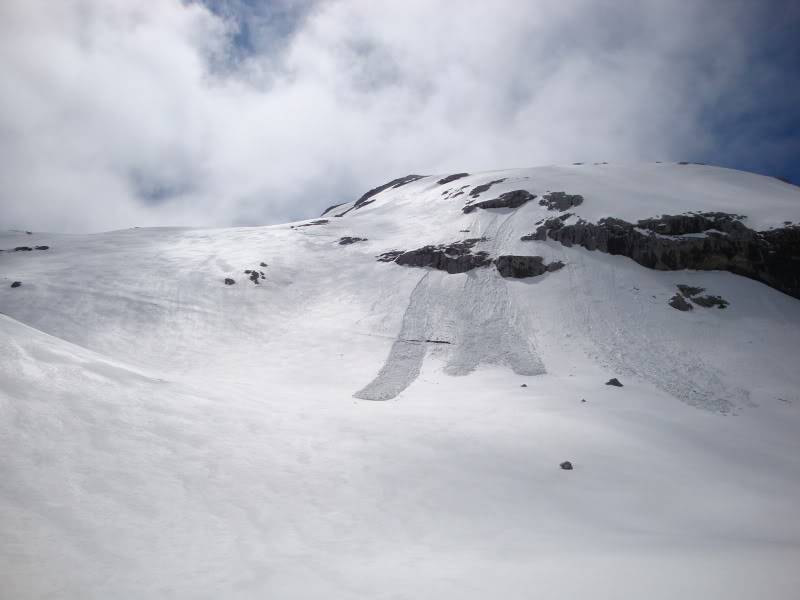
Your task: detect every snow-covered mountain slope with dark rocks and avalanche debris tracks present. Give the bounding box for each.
[0,163,800,599]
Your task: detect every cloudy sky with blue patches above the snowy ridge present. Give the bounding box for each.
[0,0,800,232]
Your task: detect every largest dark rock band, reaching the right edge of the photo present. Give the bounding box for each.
[522,212,800,298]
